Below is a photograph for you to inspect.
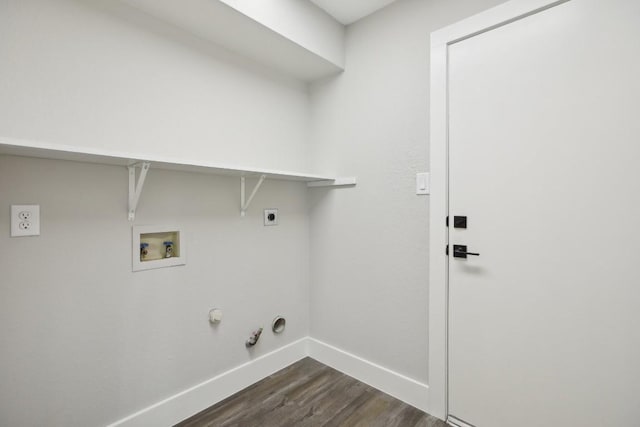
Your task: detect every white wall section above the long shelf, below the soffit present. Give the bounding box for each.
[0,0,309,174]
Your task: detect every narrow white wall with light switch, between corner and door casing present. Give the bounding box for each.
[310,0,508,383]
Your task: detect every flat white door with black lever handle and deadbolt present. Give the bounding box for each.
[448,0,640,427]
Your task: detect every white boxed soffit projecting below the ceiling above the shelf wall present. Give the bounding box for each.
[117,0,344,81]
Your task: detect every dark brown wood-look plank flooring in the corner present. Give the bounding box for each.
[177,358,446,427]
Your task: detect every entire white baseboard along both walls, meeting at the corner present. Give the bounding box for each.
[107,337,429,427]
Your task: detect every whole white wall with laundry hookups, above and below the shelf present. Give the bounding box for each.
[0,0,309,427]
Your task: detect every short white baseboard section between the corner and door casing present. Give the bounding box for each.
[308,338,429,412]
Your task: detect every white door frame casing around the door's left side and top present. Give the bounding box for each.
[428,0,572,419]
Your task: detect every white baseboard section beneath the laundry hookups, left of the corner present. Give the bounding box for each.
[108,337,308,427]
